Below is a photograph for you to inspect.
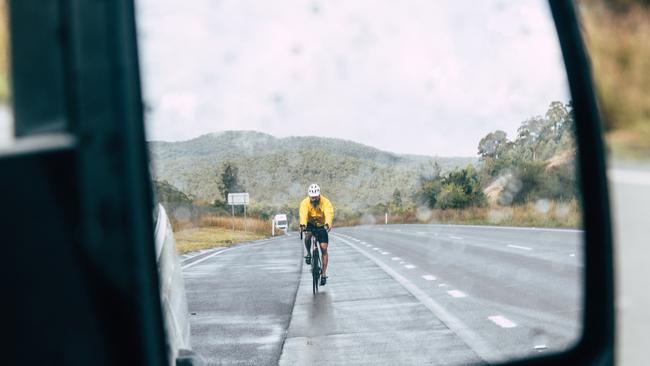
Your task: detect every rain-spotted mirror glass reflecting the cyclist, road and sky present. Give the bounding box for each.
[138,0,583,365]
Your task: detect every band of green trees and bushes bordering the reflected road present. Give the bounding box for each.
[156,102,581,233]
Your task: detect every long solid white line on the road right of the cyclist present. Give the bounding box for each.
[332,234,498,363]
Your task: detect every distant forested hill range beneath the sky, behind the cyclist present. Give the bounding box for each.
[149,131,477,209]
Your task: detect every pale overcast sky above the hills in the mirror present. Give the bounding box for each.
[138,0,570,156]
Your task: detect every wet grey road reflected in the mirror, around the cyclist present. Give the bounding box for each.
[184,225,582,365]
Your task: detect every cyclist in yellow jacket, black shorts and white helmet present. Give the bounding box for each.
[300,184,334,286]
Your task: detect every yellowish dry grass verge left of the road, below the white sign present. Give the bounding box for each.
[174,227,265,254]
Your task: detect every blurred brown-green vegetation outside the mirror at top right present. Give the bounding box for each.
[578,0,650,159]
